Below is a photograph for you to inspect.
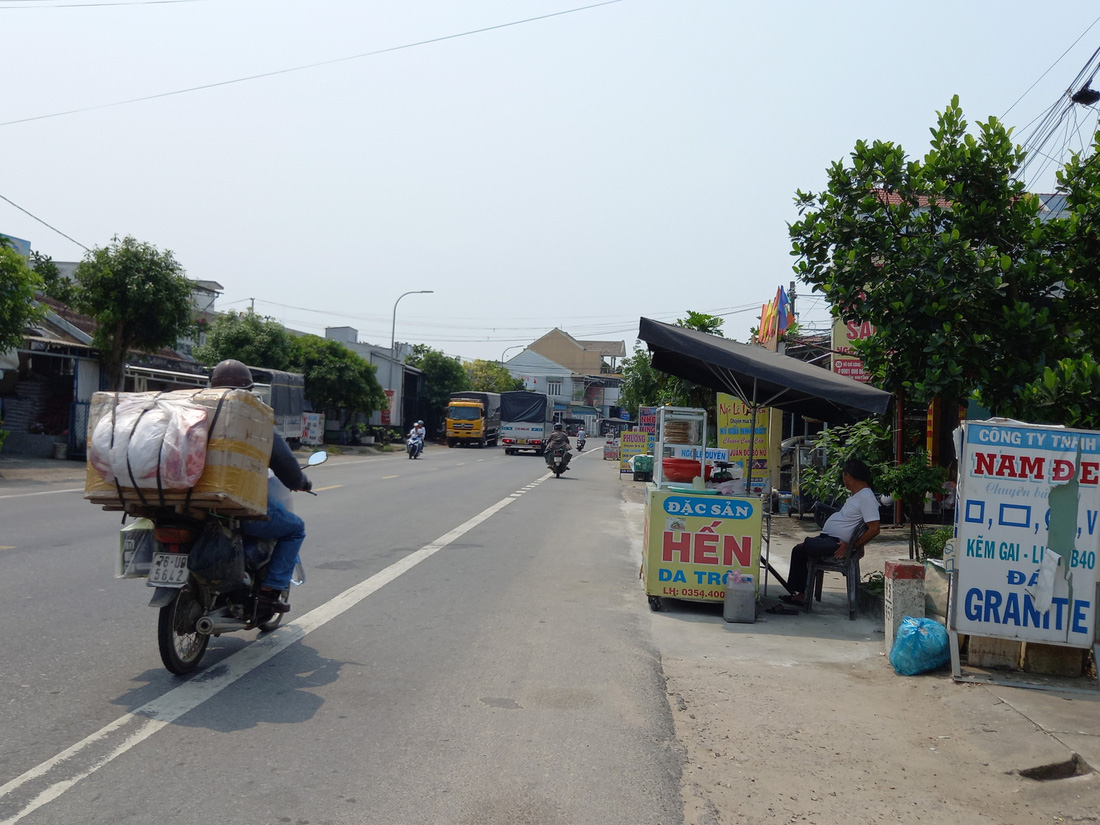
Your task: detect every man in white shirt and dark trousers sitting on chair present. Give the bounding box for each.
[781,459,879,604]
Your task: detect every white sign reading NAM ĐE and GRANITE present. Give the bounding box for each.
[953,419,1100,648]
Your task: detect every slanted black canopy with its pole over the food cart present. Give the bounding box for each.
[638,318,891,590]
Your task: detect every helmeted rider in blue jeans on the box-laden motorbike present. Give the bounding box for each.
[210,359,314,613]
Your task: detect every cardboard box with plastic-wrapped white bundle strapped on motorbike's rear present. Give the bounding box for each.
[84,388,274,516]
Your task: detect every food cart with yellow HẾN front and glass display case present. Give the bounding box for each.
[641,407,763,611]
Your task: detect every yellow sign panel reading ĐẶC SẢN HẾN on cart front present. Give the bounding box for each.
[642,492,761,602]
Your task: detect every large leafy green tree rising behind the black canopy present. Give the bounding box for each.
[790,97,1077,420]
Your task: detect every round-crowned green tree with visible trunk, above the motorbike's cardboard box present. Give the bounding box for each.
[74,235,194,389]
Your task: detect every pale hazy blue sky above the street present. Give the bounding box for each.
[0,0,1100,360]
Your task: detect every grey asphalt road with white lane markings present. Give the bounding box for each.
[0,447,682,825]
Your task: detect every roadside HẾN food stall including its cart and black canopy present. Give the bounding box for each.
[638,318,891,609]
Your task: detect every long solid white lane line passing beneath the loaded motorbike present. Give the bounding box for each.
[0,488,528,825]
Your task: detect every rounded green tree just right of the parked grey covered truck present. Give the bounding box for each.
[289,336,386,416]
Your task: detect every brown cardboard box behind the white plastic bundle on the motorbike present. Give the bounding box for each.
[84,388,275,517]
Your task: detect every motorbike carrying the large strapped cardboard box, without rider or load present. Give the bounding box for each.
[146,452,328,675]
